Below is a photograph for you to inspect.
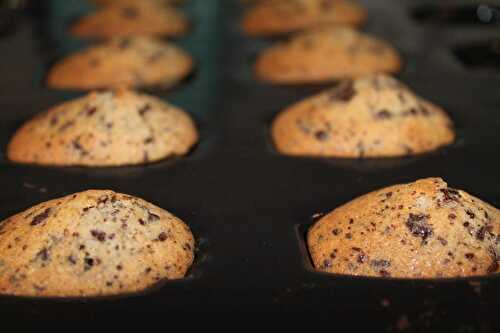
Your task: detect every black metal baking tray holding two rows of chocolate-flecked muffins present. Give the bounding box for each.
[0,0,500,326]
